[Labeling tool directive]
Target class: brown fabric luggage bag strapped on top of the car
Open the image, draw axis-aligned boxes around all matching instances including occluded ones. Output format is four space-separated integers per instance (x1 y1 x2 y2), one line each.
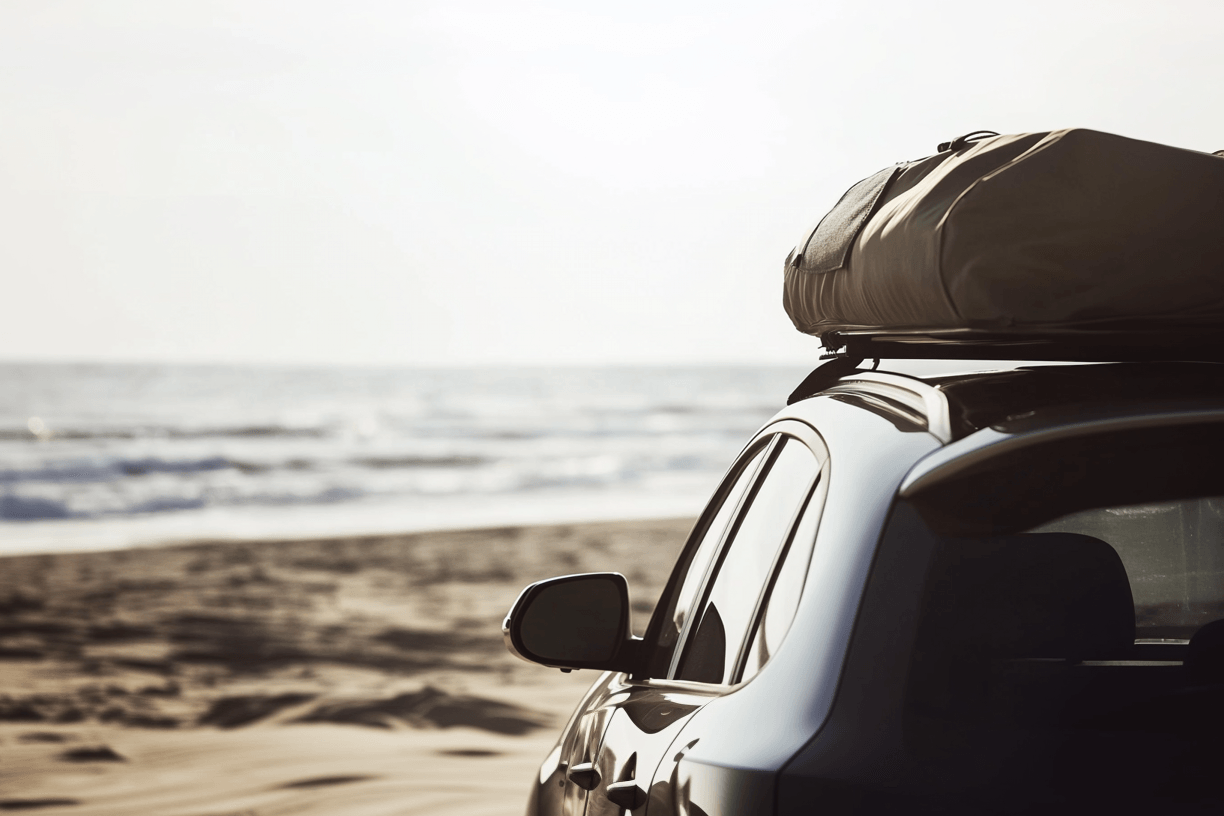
783 130 1224 358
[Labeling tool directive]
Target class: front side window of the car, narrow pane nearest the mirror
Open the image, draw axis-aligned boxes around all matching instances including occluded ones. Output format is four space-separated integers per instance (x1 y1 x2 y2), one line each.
647 437 772 677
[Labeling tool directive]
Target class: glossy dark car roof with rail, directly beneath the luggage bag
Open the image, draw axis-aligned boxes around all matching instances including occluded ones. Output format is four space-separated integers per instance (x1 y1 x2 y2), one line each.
819 360 1224 443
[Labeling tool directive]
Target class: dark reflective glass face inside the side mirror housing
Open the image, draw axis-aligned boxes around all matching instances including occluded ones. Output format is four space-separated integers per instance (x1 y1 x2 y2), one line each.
520 577 625 662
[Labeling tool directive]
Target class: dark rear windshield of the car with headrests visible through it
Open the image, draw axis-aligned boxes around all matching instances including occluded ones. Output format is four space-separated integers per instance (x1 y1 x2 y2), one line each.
905 498 1224 814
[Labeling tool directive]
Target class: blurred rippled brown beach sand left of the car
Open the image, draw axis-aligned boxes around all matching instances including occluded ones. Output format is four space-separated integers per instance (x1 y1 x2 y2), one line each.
0 519 692 816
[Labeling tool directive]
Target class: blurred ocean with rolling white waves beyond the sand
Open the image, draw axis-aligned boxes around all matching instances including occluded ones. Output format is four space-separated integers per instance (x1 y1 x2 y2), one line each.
0 363 807 554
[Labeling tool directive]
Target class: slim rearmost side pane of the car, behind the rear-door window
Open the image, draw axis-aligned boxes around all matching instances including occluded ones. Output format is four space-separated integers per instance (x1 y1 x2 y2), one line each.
736 464 824 680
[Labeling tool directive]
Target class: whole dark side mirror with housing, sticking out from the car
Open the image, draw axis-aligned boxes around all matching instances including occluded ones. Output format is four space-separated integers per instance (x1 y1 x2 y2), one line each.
502 573 641 672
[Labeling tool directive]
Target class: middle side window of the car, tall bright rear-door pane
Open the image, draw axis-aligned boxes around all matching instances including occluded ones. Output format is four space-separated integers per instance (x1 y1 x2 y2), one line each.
676 438 820 683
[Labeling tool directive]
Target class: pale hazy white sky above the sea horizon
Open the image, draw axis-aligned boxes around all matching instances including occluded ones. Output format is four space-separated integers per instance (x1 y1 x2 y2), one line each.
0 0 1224 365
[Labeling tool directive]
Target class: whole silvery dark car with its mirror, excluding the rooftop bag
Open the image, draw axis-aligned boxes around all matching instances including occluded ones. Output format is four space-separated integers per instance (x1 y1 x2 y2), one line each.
506 362 1224 816
